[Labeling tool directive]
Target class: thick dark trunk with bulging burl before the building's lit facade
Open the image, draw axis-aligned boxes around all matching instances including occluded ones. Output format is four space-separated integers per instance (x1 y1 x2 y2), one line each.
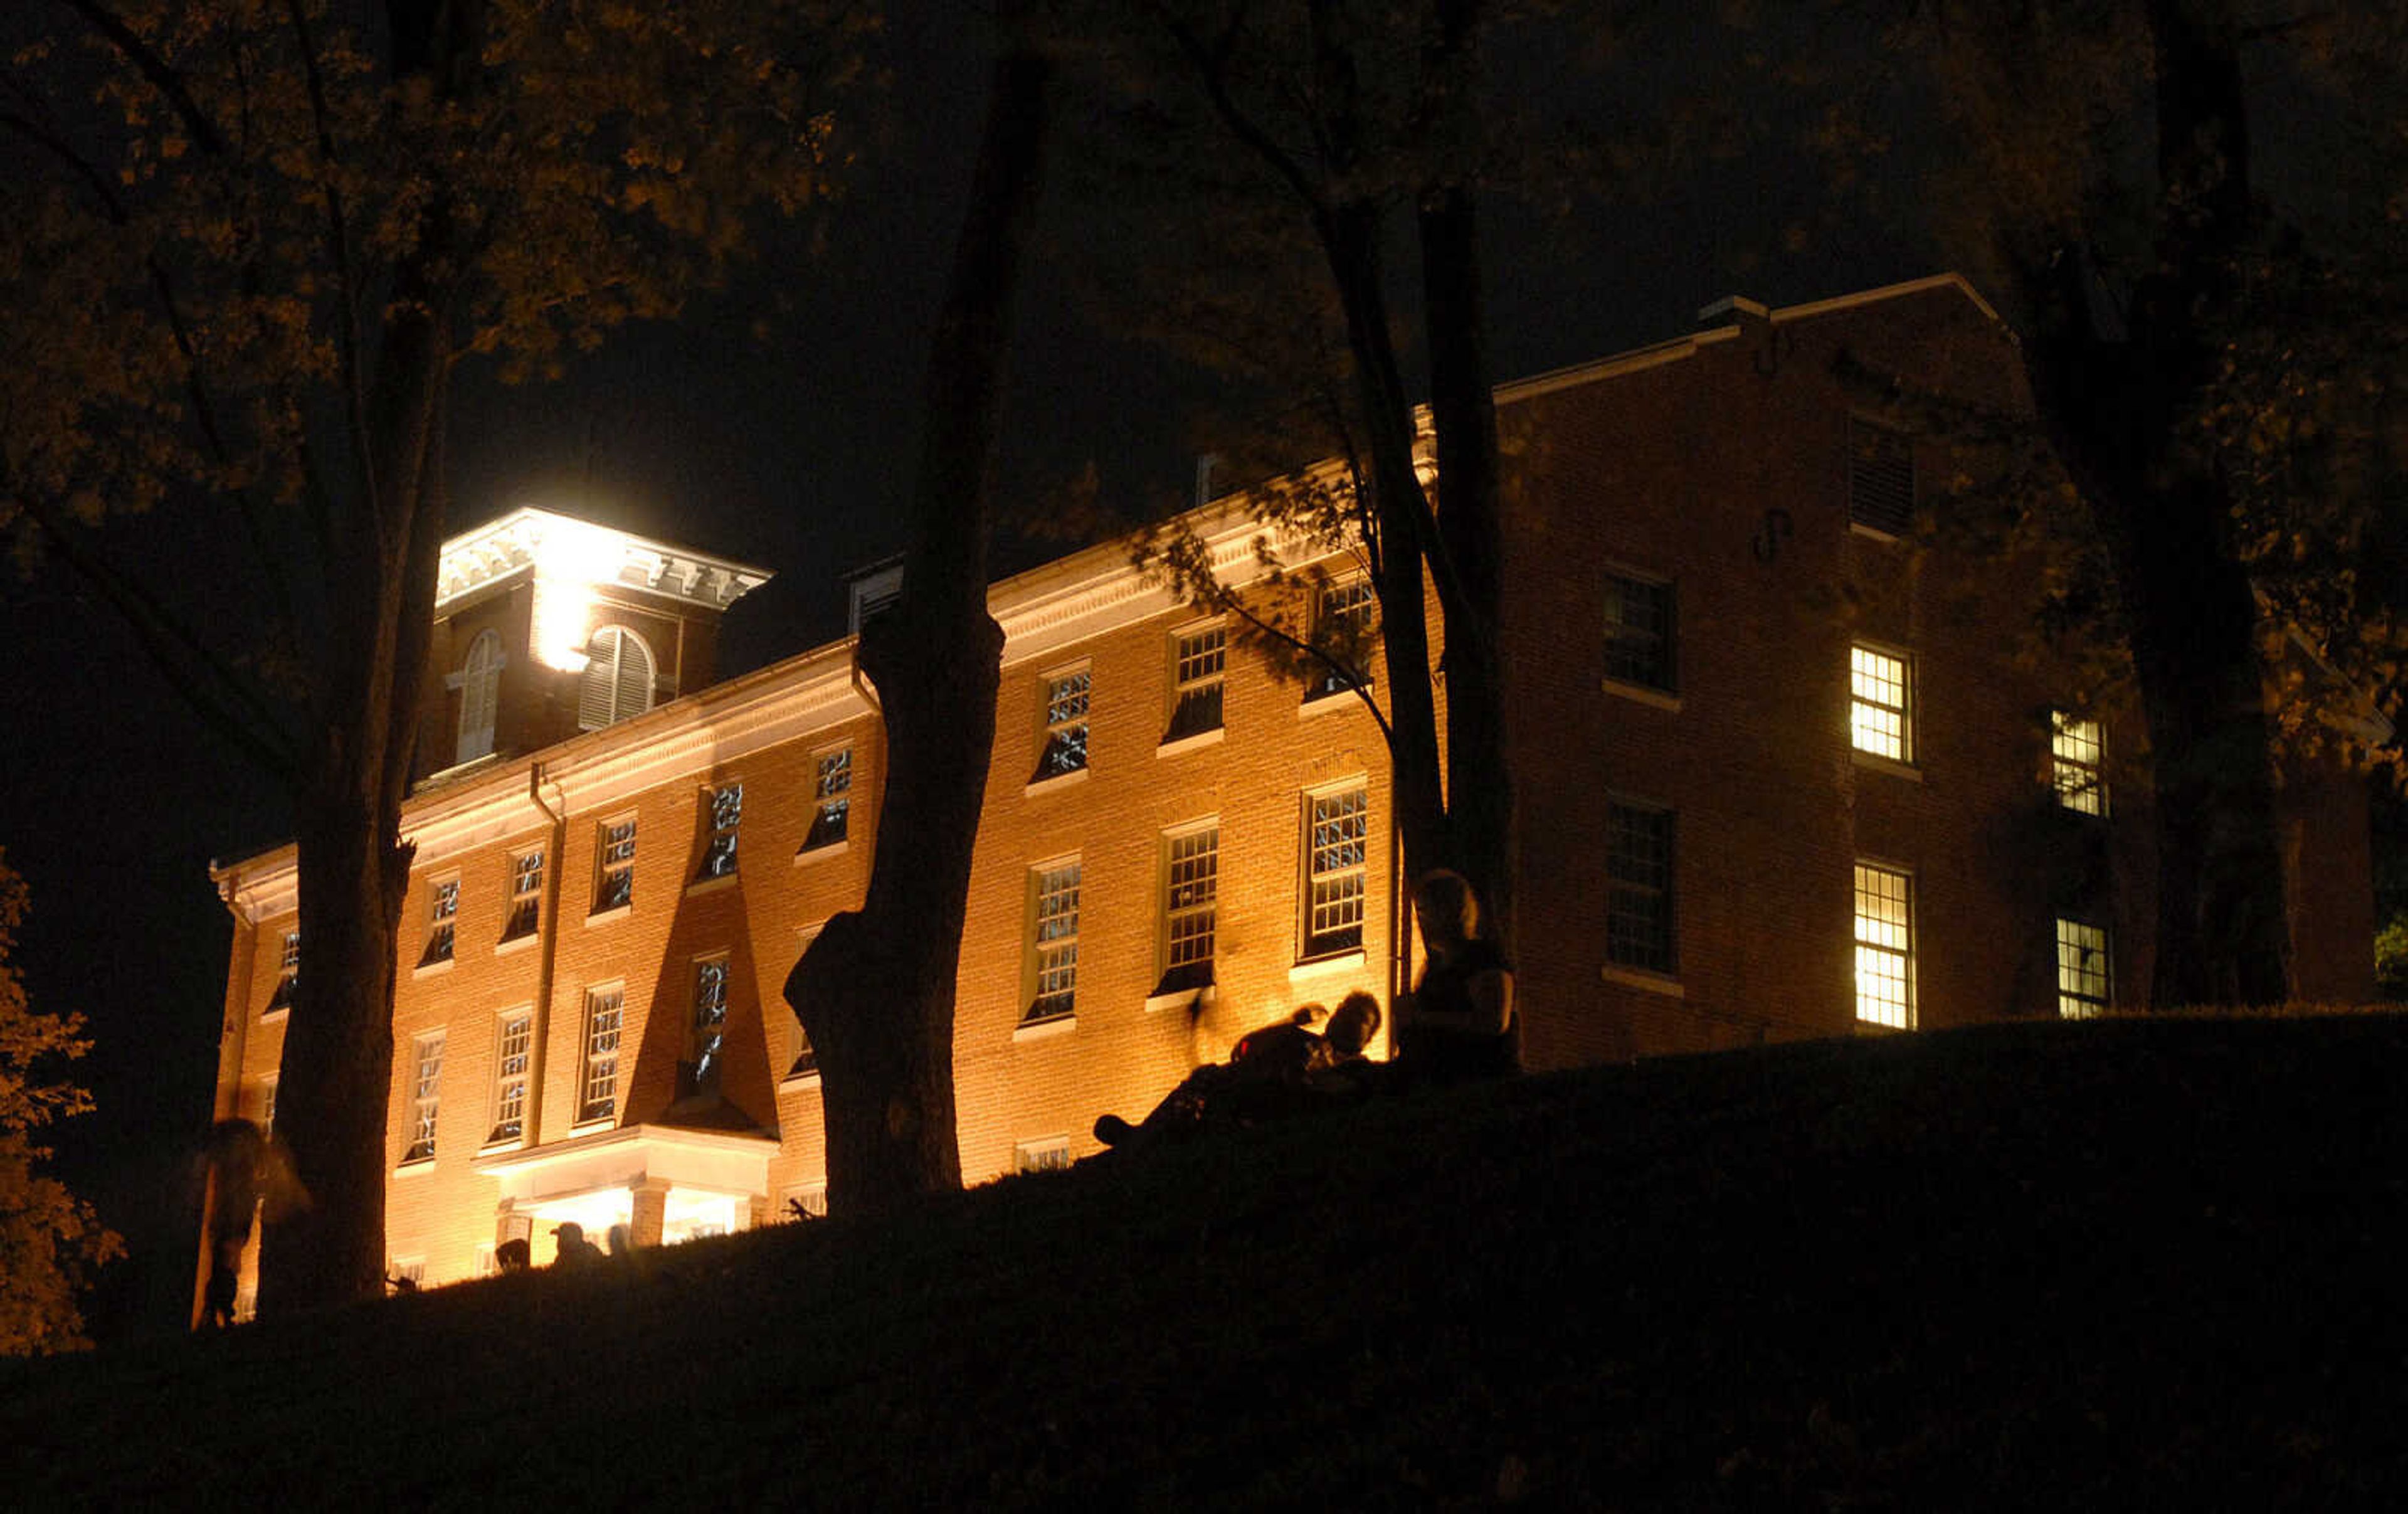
785 19 1050 1213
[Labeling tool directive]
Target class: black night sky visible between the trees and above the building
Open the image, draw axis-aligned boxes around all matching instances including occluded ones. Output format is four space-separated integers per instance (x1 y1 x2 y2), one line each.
0 5 1938 1336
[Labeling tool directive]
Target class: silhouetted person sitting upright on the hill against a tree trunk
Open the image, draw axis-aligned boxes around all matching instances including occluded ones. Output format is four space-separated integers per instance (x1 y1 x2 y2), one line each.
1397 869 1522 1086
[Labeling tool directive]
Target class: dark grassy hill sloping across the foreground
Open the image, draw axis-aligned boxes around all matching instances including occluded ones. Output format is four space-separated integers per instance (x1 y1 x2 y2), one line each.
0 1016 2408 1509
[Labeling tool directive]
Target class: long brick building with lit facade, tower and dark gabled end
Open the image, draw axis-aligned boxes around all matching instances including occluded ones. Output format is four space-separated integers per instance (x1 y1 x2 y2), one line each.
202 277 2372 1283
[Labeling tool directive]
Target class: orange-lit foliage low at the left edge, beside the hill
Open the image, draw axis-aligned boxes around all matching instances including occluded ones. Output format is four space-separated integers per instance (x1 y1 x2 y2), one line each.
0 852 125 1355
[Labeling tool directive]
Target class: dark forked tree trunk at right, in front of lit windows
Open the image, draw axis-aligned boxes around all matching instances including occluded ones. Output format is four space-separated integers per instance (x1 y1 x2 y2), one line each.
2013 0 2293 1006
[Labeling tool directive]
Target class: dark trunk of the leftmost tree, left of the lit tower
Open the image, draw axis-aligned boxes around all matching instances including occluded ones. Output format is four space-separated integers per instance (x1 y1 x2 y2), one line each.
260 3 474 1314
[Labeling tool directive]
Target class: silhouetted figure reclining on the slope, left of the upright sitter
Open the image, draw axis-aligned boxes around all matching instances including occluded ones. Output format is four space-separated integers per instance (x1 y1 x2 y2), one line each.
1096 992 1380 1148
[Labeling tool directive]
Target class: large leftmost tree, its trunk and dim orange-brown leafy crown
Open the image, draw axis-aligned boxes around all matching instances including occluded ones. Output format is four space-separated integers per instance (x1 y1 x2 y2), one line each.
0 0 862 1307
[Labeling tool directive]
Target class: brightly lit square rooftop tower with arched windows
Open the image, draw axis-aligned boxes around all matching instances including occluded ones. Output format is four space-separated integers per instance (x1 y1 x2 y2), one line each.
414 508 768 782
